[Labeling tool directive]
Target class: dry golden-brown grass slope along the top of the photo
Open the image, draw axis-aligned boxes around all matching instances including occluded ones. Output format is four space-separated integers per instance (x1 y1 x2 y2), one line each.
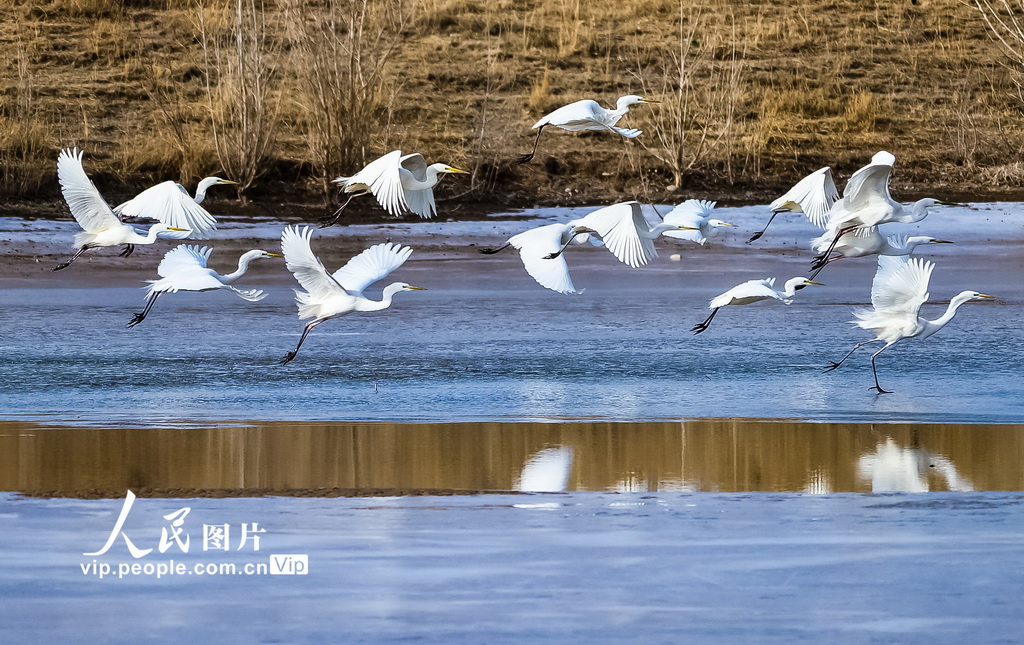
6 0 1024 203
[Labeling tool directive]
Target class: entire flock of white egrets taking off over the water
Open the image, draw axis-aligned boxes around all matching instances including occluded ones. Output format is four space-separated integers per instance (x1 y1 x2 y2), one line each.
48 95 992 394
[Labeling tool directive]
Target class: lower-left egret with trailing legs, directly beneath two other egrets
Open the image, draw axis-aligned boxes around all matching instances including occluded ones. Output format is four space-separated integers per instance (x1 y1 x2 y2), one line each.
128 245 282 328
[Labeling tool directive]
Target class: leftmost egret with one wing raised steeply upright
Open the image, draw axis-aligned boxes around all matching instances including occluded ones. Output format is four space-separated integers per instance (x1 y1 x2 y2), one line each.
53 147 188 271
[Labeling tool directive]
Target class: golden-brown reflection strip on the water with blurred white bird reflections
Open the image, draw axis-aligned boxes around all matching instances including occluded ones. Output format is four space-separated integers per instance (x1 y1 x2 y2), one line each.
0 420 1024 497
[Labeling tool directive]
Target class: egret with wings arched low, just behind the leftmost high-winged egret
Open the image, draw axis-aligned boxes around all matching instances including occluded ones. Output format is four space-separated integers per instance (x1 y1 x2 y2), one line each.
114 177 238 240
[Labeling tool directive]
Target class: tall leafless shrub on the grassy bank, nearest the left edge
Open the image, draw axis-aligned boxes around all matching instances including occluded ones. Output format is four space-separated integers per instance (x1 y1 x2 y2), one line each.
195 0 281 195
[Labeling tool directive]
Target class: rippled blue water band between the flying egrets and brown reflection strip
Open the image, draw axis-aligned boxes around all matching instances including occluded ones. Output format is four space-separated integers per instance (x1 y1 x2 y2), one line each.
0 250 1024 424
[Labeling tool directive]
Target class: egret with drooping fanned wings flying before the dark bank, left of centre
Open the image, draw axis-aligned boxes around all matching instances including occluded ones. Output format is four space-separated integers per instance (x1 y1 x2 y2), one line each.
321 151 469 228
